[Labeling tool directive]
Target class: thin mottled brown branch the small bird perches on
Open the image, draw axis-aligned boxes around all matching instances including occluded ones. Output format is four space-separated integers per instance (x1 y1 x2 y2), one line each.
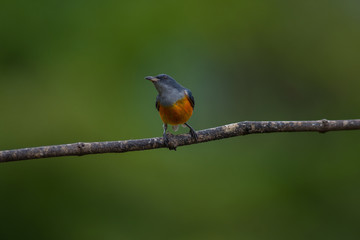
0 119 360 162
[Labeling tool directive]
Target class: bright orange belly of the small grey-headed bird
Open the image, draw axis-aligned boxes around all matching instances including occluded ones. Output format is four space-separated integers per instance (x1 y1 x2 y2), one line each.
159 97 193 125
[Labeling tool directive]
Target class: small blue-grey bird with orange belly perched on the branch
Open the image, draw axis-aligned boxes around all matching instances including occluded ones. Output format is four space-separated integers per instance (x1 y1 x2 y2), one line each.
145 74 198 144
